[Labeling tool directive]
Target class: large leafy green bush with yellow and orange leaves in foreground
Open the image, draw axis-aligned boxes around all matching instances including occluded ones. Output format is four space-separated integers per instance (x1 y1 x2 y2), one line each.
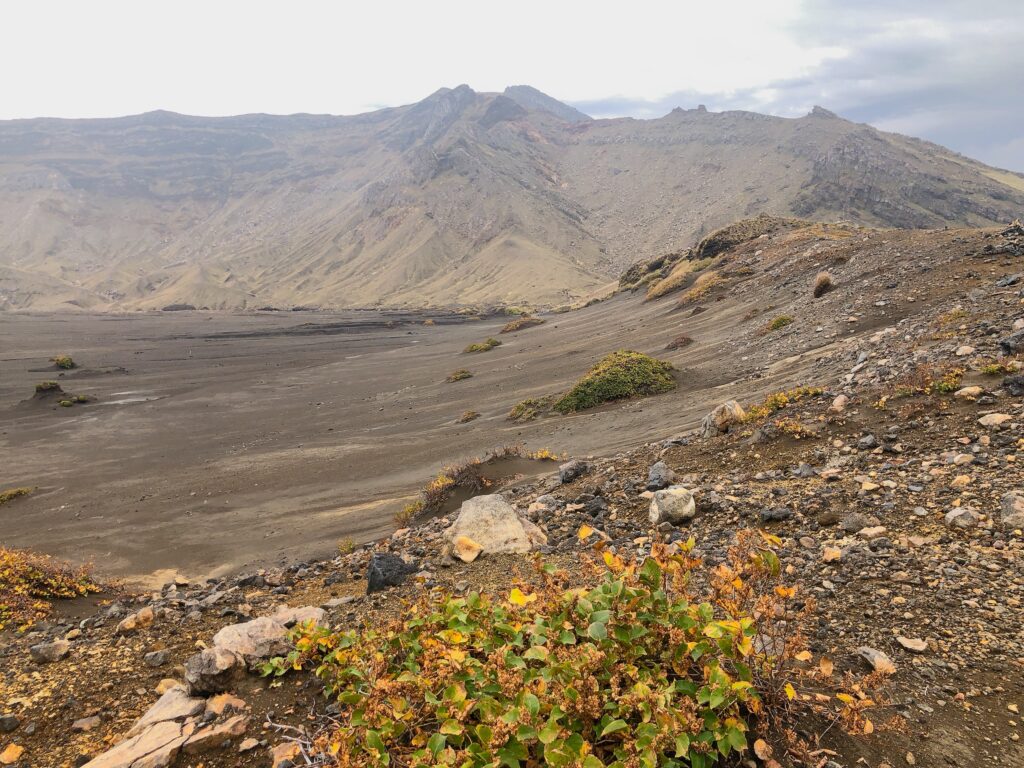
262 530 798 768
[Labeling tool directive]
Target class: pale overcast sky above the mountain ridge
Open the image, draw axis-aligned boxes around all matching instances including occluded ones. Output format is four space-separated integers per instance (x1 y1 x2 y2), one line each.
0 0 1024 171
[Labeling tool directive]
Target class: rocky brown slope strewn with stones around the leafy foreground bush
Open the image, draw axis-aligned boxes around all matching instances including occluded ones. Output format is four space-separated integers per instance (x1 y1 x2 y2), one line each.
0 222 1024 768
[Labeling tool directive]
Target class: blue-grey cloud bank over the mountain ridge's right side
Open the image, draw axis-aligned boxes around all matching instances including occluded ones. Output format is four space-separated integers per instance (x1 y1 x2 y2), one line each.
572 0 1024 172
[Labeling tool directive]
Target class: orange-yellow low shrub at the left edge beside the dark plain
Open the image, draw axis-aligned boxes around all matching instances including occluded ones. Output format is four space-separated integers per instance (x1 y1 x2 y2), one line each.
0 547 100 630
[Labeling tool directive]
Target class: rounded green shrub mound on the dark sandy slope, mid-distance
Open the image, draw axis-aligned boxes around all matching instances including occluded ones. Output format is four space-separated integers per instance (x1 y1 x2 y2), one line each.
554 349 676 414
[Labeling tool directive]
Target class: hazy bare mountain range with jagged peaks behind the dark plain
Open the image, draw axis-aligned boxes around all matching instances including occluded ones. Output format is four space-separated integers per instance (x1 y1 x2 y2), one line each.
0 85 1024 310
